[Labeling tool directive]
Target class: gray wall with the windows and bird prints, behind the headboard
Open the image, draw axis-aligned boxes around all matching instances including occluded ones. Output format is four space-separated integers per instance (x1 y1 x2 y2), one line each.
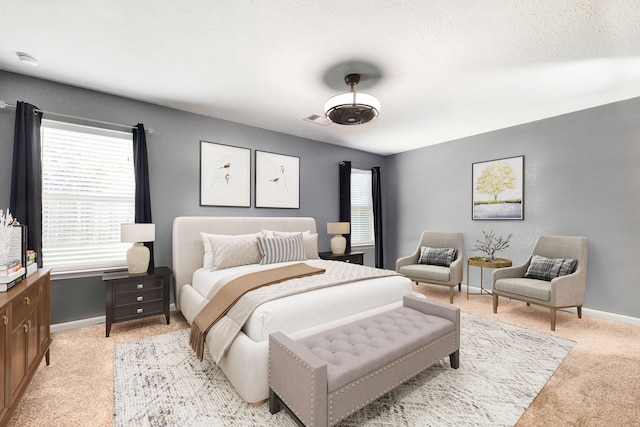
0 71 385 324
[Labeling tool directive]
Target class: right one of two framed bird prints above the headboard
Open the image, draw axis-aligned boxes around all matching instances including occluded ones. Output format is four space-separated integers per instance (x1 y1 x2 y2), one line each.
256 150 300 209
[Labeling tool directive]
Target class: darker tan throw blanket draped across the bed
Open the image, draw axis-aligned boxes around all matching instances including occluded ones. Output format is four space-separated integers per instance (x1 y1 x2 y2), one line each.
189 263 325 360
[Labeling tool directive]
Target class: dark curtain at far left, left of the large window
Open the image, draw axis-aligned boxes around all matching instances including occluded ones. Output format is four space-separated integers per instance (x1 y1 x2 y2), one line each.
9 101 42 267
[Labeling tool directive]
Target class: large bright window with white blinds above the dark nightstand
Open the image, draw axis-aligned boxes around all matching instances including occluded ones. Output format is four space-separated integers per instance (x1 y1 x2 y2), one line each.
42 120 135 272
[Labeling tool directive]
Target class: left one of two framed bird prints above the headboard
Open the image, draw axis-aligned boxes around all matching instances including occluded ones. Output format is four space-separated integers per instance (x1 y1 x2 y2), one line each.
200 141 251 208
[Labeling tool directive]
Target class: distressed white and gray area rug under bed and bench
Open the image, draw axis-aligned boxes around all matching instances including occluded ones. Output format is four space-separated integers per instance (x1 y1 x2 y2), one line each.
113 313 575 427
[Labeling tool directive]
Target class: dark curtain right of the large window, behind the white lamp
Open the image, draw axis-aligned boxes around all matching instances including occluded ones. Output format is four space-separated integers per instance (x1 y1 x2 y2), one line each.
133 123 155 273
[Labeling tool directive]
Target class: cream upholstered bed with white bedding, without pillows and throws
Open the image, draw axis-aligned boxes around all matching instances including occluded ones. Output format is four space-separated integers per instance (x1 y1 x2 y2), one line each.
172 217 411 404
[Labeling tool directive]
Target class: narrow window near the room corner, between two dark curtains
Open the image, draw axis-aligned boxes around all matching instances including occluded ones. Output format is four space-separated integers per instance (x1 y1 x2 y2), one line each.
351 168 375 246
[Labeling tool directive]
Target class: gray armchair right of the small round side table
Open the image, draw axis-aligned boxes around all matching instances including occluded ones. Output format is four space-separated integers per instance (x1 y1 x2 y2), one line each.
492 236 587 331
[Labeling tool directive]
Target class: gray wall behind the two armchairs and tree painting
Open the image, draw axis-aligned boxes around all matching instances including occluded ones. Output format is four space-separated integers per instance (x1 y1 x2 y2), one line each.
385 98 640 317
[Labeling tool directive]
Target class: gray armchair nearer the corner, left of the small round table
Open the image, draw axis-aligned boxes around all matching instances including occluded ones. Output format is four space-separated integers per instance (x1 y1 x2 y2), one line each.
396 231 464 304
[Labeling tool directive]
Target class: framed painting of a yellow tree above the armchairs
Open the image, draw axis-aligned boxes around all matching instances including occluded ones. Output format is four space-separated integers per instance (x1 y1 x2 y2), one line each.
472 156 524 219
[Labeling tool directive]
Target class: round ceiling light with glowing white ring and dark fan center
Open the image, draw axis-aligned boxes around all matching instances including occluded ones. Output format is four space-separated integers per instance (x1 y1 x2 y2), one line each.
324 74 380 125
